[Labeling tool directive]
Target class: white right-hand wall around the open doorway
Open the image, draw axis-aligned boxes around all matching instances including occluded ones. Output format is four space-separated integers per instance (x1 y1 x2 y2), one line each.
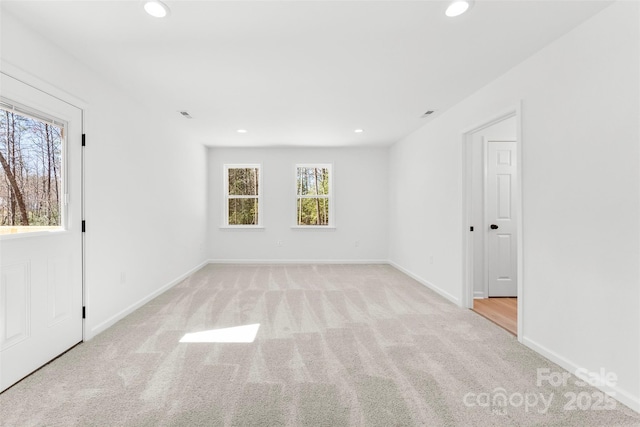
389 1 640 410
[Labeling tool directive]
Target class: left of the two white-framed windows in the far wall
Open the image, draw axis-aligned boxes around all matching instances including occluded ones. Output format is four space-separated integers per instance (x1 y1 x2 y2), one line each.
224 165 262 227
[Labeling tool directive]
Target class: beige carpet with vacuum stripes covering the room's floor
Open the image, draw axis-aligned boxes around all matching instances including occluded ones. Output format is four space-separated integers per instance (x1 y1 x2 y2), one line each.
0 265 640 427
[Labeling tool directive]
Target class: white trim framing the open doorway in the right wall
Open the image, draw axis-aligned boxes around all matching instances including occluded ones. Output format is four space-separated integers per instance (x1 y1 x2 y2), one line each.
461 101 525 342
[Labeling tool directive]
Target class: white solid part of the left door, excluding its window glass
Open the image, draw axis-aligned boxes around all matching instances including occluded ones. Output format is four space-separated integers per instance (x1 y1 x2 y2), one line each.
0 74 83 390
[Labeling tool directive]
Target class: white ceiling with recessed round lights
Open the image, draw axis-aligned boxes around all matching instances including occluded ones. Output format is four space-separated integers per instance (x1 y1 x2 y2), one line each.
1 0 610 146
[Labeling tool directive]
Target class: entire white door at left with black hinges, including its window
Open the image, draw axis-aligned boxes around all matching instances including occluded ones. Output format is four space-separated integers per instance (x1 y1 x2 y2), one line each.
0 74 83 391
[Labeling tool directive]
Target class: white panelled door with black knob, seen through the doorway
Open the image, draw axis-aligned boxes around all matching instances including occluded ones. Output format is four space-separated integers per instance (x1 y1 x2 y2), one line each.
485 140 518 297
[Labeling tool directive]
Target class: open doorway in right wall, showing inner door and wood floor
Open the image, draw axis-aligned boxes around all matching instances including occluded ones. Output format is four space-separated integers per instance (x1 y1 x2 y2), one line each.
463 107 523 337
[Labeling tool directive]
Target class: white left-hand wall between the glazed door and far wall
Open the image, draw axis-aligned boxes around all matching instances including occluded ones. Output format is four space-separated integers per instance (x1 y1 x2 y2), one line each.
1 12 206 339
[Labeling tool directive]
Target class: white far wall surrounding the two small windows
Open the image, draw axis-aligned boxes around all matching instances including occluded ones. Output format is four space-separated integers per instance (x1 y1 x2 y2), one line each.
208 148 388 262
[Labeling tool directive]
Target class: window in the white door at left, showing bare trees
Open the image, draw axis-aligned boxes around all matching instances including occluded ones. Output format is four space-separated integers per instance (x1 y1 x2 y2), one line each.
0 101 65 234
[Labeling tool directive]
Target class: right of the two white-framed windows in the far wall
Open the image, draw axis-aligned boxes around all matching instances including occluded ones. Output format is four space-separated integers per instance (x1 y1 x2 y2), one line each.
296 164 333 227
